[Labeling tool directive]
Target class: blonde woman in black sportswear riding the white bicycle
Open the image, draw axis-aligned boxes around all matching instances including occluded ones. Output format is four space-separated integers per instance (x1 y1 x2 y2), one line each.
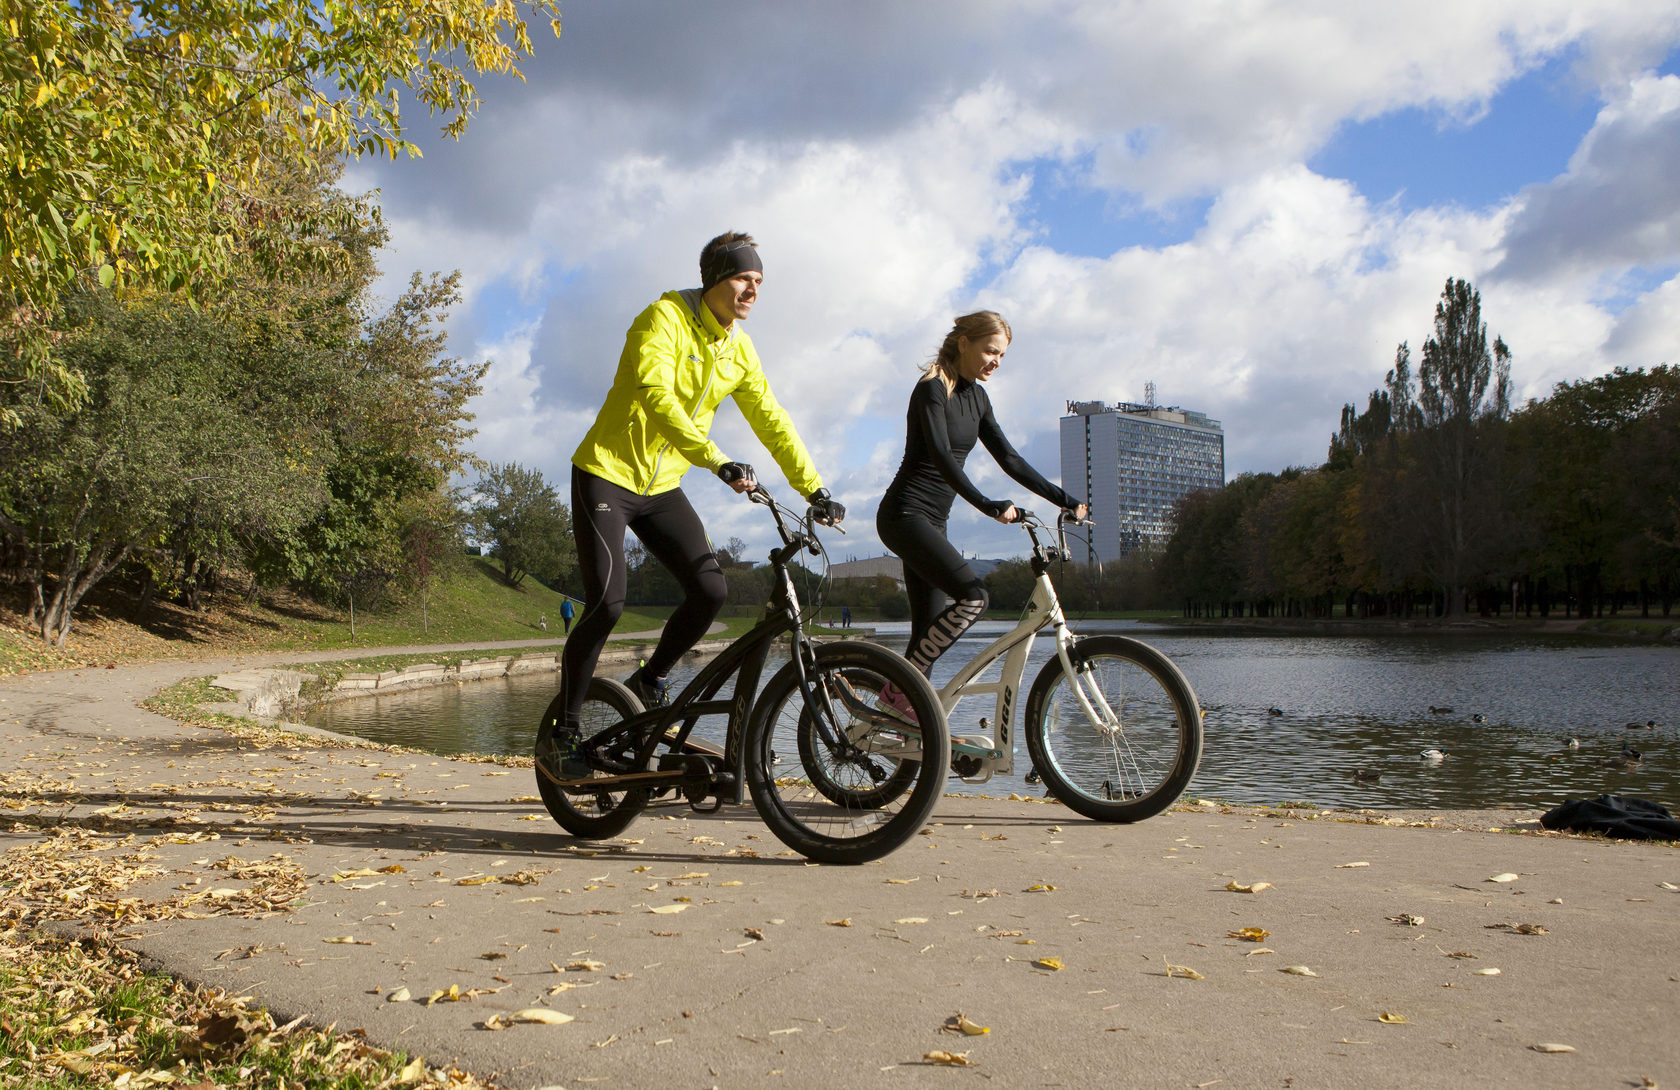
875 311 1087 710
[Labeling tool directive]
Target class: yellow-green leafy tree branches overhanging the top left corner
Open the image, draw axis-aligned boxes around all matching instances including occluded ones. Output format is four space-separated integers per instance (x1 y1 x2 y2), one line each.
0 0 559 418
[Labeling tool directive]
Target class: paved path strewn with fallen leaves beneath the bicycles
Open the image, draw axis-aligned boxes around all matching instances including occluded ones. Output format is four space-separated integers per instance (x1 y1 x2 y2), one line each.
0 648 1680 1090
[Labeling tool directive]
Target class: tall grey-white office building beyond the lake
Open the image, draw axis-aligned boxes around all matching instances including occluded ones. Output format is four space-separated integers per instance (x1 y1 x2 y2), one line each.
1062 398 1225 561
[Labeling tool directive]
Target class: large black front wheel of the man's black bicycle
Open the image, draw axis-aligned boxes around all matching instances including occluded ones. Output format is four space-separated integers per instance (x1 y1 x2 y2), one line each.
744 642 951 863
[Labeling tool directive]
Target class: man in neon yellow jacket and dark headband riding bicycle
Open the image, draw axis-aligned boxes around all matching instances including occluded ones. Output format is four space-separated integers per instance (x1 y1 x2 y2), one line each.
536 232 845 783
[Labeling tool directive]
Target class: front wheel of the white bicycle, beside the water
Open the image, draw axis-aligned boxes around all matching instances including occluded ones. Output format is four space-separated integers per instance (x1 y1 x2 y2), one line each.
1025 635 1201 821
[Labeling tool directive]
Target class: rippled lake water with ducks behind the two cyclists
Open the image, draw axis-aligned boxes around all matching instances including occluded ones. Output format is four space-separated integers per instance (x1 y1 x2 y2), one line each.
309 621 1680 810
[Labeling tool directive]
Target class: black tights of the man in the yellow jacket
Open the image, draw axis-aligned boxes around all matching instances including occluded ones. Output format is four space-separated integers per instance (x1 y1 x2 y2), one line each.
559 465 729 722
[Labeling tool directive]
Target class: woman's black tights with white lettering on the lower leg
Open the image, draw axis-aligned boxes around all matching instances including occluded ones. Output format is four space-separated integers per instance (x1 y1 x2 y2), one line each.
875 516 988 675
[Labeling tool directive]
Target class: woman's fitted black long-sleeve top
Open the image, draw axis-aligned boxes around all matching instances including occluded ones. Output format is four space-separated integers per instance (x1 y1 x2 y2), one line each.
880 376 1079 522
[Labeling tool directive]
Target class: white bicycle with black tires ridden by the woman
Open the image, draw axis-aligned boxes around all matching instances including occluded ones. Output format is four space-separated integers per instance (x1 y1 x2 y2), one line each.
798 512 1201 821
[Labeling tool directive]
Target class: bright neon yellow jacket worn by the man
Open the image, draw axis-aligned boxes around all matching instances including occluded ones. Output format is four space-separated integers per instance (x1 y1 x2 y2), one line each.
571 289 823 497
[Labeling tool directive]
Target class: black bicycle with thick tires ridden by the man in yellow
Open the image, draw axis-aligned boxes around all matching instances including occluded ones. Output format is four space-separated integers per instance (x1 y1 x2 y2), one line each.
536 489 949 863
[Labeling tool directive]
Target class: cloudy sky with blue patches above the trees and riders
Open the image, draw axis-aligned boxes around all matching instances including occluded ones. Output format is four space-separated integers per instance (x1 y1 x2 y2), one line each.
346 0 1680 559
